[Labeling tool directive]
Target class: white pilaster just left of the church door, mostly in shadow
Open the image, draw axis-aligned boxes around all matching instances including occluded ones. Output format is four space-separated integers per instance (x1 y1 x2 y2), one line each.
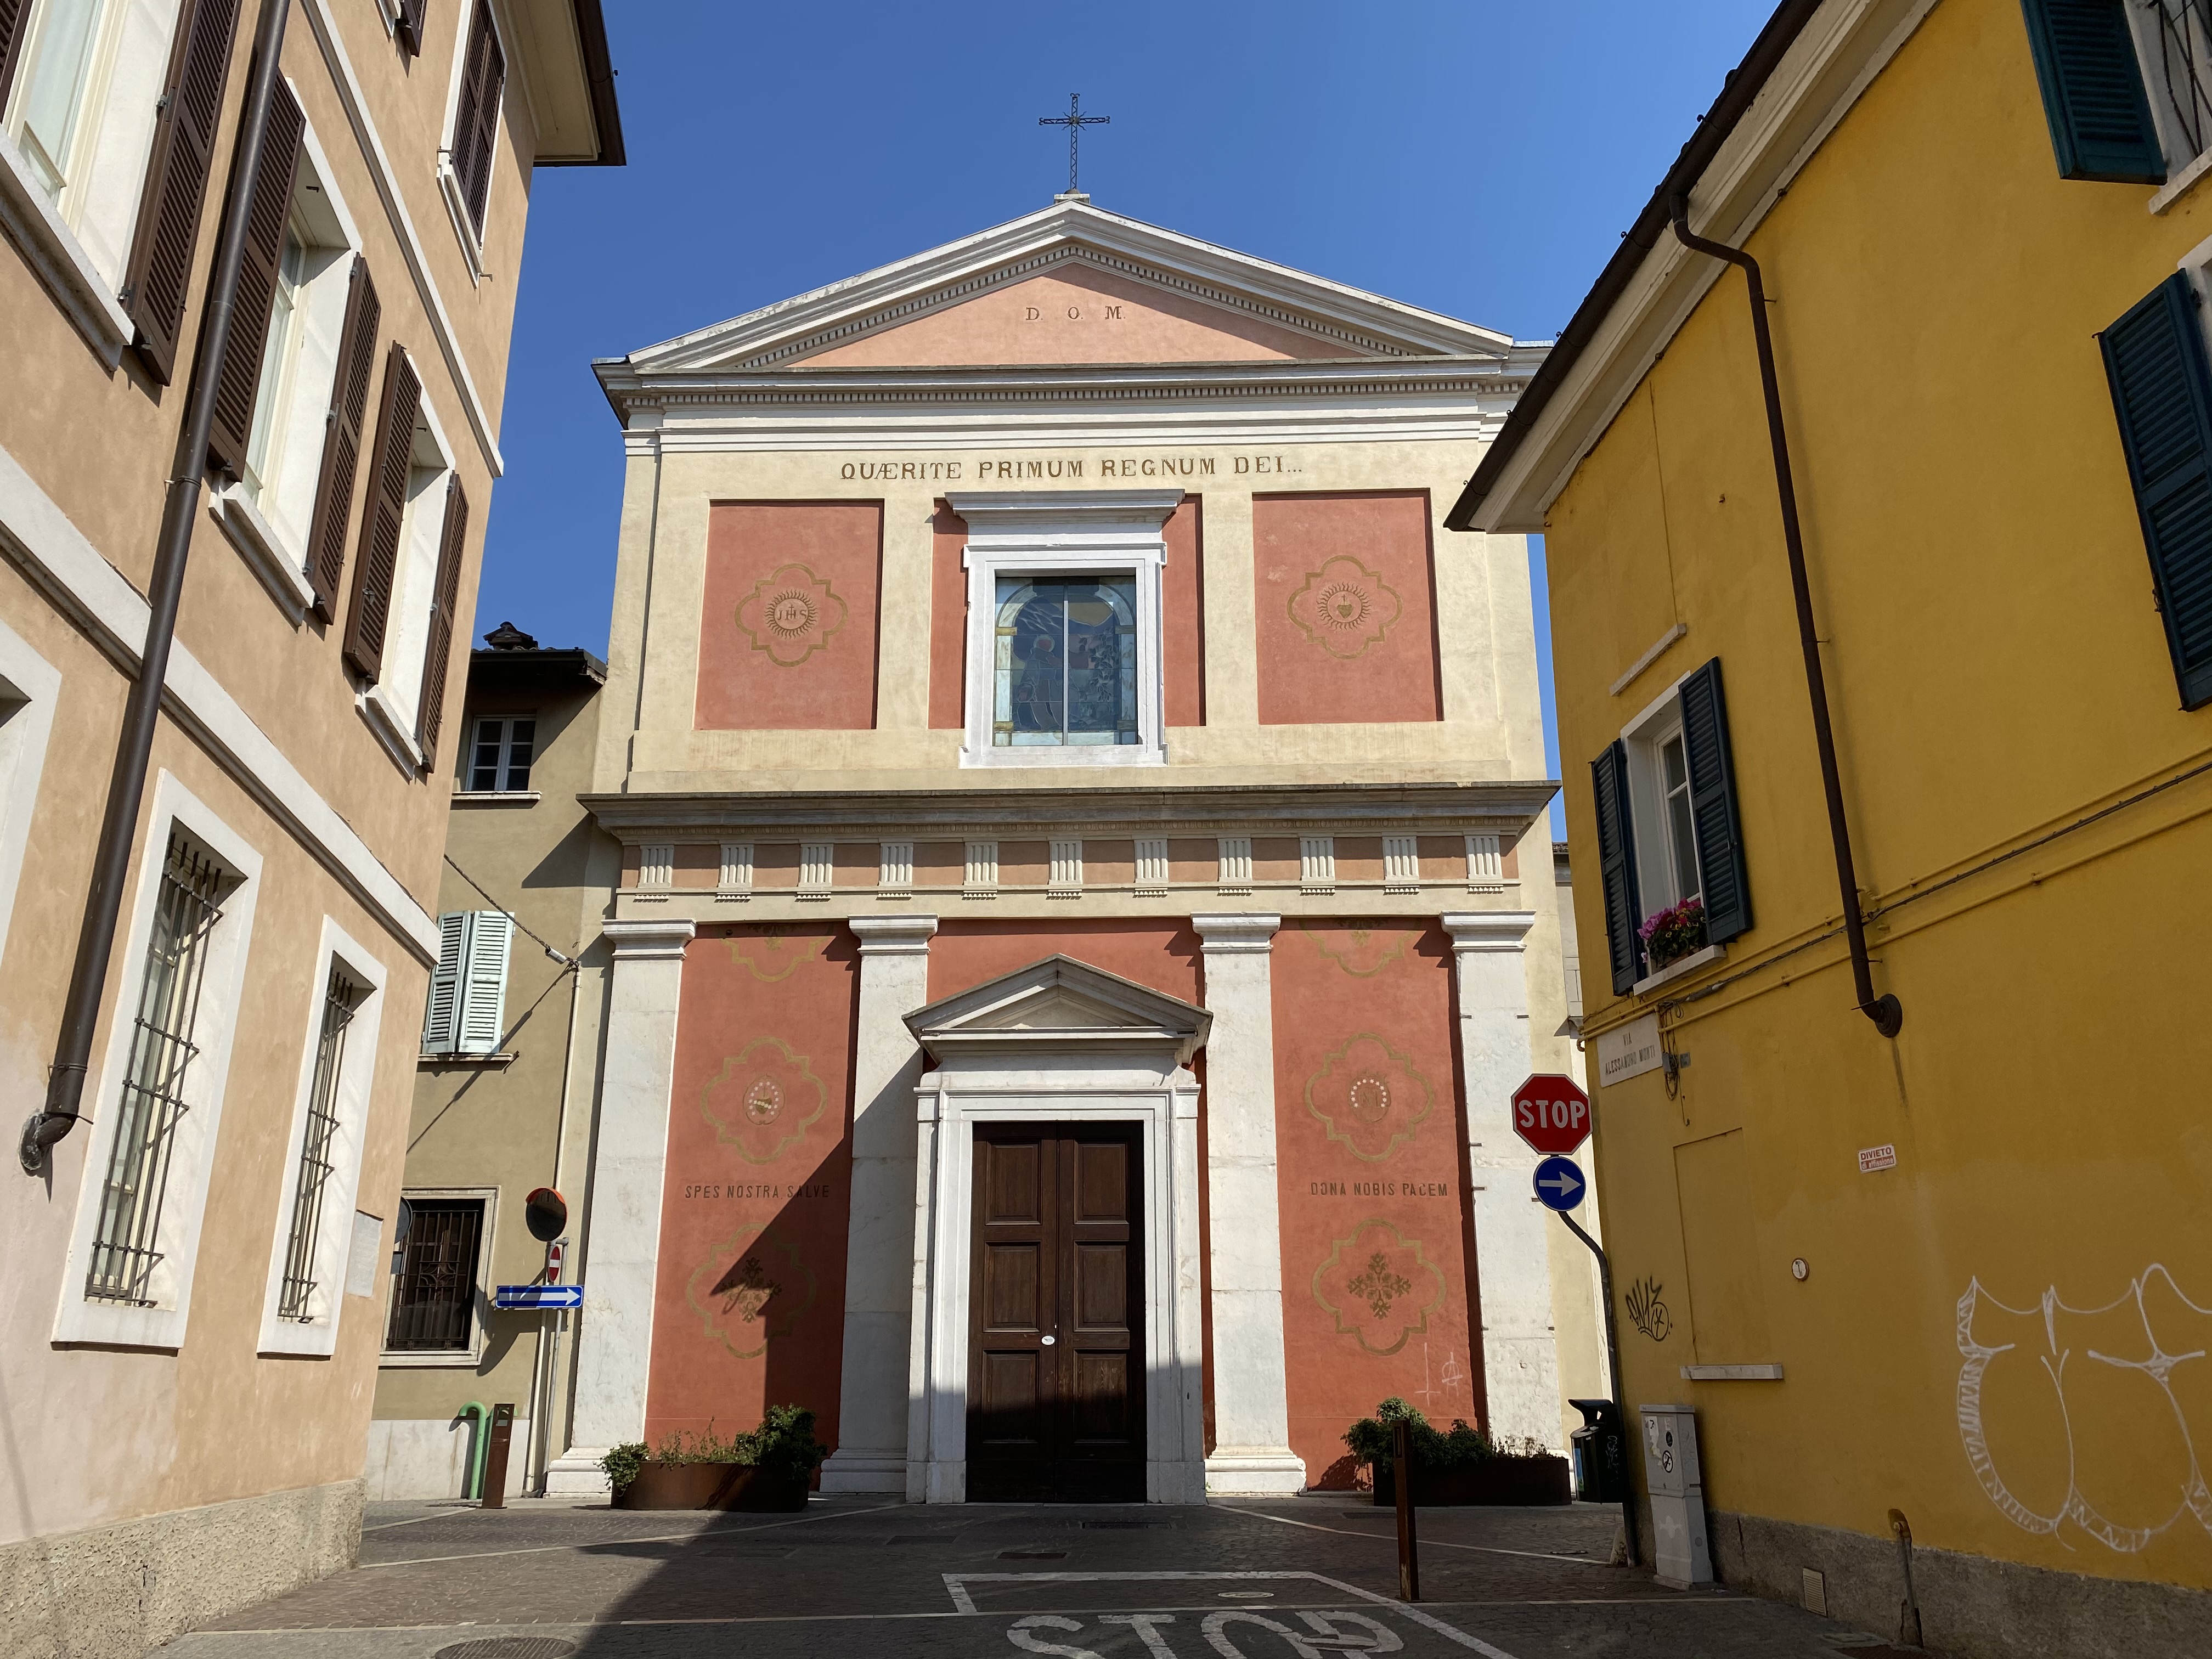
823 916 938 1493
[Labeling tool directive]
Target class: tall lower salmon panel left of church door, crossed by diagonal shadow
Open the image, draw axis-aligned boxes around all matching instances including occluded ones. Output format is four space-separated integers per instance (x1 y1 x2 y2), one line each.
646 922 860 1447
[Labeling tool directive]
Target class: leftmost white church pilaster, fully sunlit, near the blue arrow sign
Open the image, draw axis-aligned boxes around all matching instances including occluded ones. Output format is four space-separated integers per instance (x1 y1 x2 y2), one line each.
546 918 697 1496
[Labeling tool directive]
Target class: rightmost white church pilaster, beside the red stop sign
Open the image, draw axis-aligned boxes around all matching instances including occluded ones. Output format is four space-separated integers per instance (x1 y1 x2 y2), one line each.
1442 911 1560 1444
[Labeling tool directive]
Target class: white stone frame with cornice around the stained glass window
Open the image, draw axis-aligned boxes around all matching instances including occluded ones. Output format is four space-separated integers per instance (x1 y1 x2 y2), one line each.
947 489 1183 768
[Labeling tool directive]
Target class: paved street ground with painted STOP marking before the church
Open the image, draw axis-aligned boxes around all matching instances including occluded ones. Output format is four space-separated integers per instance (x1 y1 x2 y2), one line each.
168 1498 1887 1659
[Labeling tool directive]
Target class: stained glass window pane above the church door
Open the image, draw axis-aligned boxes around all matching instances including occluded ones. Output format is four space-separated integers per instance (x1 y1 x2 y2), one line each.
991 575 1139 748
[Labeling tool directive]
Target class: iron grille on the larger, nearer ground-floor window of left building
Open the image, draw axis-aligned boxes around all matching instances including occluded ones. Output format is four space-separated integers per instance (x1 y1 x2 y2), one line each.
84 830 230 1307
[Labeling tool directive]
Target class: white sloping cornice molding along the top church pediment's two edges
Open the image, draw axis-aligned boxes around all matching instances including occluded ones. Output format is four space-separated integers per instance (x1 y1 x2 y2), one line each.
624 201 1513 371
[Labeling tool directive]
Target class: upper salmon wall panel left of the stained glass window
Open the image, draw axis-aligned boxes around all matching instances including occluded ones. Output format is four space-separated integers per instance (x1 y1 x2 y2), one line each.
695 502 883 732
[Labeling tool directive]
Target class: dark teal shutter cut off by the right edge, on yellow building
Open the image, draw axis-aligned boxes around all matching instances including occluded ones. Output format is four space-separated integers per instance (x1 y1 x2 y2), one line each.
2097 272 2212 708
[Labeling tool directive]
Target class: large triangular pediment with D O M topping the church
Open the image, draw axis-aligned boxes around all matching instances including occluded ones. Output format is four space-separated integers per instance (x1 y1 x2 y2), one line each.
628 201 1513 374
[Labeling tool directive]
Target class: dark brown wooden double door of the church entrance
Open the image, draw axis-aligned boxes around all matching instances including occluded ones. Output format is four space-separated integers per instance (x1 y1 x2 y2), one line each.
967 1124 1146 1502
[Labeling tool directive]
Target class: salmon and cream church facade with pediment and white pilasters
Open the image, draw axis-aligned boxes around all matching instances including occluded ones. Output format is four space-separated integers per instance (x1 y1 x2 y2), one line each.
551 195 1604 1502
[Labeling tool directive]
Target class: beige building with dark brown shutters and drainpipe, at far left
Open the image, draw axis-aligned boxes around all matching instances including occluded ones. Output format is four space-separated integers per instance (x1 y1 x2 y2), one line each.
0 0 622 1659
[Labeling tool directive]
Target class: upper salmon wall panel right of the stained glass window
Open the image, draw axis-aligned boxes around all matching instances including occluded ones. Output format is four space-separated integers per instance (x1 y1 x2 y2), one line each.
1252 491 1444 725
